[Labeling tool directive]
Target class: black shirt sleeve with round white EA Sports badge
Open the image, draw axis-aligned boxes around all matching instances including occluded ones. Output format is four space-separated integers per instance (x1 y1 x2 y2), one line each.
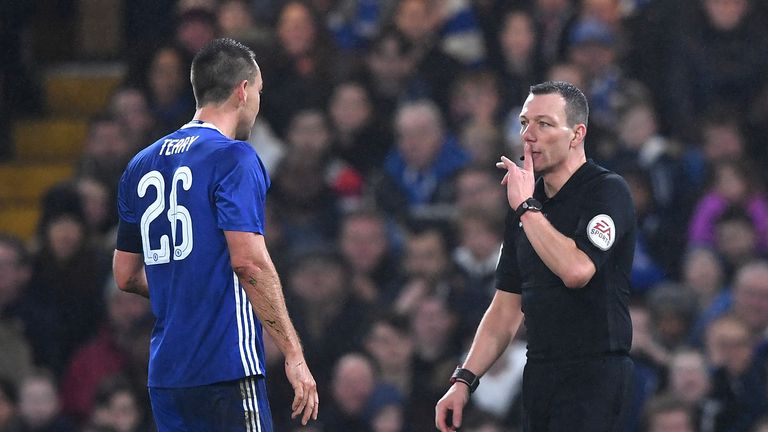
573 174 635 270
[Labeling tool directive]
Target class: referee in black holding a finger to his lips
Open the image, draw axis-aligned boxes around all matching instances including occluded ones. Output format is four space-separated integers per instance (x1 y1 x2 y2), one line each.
435 82 635 432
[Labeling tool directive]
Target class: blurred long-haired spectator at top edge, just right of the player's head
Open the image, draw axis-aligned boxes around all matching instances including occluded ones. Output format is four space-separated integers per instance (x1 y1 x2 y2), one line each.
262 0 339 136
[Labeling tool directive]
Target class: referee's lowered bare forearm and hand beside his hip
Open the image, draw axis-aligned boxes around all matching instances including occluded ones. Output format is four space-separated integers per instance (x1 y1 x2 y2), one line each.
435 290 523 432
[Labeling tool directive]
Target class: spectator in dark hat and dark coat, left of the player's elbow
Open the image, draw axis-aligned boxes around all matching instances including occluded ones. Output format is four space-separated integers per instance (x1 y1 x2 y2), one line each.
24 183 110 376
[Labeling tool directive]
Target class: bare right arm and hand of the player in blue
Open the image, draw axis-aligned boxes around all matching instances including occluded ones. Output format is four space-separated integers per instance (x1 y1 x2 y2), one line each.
224 231 319 424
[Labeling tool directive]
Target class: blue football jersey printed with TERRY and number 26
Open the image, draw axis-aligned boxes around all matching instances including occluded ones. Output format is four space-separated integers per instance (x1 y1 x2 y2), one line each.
118 121 270 387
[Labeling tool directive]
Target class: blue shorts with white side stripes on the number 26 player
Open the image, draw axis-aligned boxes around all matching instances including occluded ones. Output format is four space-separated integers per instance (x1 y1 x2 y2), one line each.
149 375 272 432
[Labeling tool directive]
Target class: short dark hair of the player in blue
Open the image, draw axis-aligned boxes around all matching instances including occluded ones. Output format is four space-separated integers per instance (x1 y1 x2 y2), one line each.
190 38 259 108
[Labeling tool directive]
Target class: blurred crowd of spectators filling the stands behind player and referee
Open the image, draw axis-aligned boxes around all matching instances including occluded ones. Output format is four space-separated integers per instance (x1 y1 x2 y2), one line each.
0 0 768 432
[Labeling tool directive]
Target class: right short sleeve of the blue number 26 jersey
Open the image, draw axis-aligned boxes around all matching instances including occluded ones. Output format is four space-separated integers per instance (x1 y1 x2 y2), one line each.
213 141 269 234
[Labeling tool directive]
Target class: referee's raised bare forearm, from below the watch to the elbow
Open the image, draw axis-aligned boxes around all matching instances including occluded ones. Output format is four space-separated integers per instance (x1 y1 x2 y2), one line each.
520 211 597 288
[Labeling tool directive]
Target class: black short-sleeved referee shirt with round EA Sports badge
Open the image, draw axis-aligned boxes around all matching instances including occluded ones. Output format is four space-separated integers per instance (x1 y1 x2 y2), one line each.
496 160 636 362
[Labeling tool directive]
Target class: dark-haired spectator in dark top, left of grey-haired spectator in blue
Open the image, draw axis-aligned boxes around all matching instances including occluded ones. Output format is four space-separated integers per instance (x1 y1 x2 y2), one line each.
328 80 392 175
